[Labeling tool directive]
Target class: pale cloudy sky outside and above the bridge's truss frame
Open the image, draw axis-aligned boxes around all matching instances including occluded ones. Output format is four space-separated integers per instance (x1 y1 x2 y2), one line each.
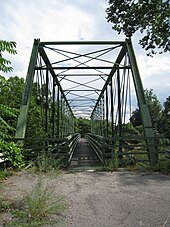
0 0 170 103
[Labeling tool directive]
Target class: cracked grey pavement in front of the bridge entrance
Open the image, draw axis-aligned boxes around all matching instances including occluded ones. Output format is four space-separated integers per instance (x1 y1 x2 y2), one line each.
3 171 170 227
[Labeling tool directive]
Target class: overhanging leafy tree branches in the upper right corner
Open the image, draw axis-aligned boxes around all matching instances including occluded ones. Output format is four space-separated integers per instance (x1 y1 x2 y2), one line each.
106 0 170 55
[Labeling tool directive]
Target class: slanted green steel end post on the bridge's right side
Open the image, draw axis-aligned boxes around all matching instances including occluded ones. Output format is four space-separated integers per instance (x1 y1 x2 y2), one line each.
126 39 158 164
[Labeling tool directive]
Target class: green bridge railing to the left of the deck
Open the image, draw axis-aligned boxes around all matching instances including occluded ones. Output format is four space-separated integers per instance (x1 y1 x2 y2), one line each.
14 133 80 166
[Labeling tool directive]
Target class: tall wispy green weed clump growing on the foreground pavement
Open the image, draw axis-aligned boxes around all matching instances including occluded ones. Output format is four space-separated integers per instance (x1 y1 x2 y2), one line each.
8 179 67 227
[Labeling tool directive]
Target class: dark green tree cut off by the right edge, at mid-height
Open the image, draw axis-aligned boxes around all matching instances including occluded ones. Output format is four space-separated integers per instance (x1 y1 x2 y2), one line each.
160 96 170 137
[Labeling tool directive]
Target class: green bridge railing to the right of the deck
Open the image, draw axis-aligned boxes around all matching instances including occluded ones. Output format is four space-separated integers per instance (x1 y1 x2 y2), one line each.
86 133 170 164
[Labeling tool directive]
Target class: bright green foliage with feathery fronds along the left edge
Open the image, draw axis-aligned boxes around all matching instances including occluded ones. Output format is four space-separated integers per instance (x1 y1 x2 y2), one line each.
0 40 24 168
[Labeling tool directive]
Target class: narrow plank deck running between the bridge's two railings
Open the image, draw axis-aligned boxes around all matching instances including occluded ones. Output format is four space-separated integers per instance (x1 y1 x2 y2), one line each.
70 138 100 167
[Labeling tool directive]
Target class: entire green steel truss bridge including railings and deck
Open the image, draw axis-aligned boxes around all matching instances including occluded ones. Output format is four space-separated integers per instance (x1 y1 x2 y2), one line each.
15 39 169 166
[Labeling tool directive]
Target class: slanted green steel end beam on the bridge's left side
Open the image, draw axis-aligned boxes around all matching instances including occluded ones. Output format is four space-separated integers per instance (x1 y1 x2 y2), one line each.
15 39 40 138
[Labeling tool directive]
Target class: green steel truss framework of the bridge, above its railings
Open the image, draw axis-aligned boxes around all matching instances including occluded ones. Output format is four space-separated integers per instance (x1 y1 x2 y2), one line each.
16 39 157 163
